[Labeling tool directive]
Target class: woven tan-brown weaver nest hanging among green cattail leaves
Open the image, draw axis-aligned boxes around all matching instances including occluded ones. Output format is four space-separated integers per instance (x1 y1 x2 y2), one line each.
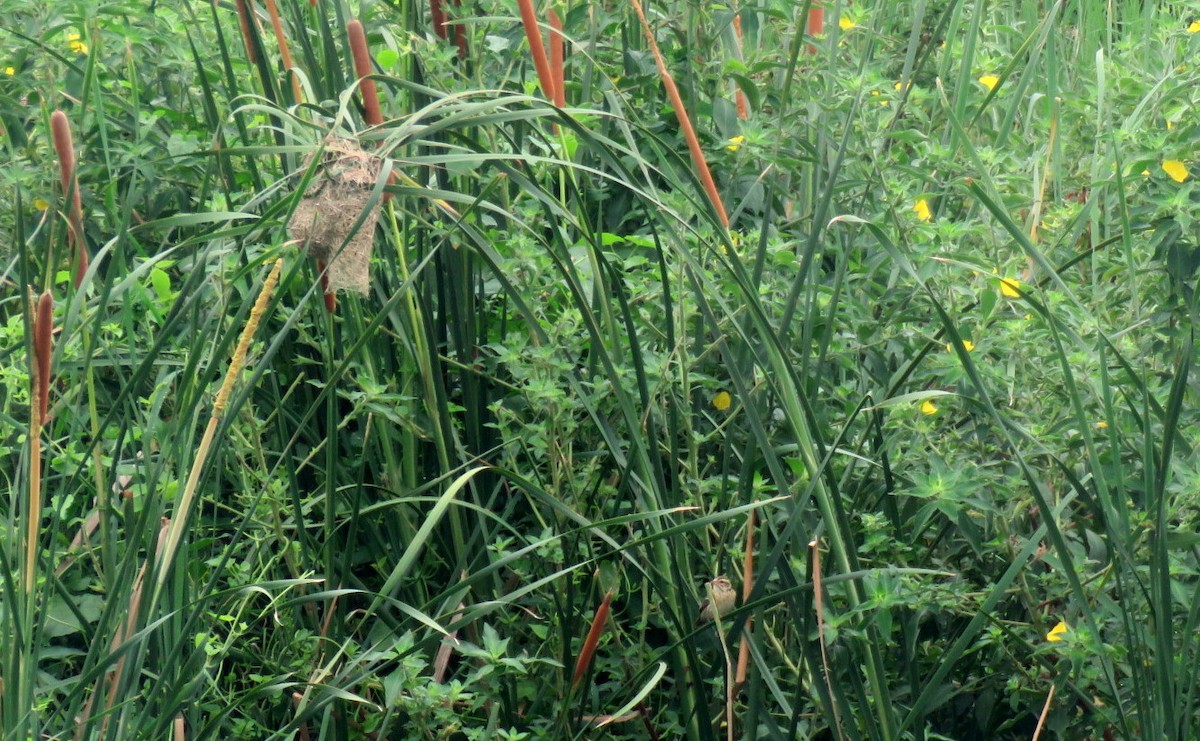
288 137 382 294
